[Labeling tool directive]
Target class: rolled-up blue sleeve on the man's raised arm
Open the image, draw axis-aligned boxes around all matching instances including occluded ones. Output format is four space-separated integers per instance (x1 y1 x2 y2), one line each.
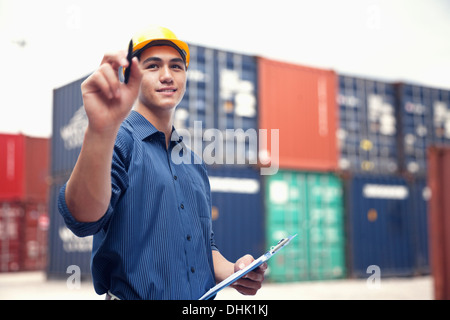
58 127 132 237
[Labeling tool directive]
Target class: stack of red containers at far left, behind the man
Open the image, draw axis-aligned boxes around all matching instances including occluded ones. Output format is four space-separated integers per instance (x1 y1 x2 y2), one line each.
0 134 49 272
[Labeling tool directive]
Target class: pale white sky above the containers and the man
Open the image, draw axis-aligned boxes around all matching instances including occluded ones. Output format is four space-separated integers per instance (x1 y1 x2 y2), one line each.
0 0 450 137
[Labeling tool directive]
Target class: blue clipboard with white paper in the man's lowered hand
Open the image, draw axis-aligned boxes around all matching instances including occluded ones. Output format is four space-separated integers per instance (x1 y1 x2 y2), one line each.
199 234 297 300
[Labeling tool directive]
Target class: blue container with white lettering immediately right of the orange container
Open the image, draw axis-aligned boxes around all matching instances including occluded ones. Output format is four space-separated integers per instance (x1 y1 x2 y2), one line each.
337 75 399 174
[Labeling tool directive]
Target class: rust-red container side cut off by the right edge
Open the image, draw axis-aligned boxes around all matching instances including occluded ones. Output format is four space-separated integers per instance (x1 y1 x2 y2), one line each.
428 148 450 300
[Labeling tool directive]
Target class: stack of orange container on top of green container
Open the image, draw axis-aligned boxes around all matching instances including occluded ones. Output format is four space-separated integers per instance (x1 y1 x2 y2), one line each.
258 58 346 282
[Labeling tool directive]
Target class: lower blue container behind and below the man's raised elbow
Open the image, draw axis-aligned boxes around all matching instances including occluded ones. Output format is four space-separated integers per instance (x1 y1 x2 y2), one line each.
47 176 93 278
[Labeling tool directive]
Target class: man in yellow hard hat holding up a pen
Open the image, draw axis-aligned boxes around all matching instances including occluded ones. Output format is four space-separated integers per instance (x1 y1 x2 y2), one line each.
58 27 267 299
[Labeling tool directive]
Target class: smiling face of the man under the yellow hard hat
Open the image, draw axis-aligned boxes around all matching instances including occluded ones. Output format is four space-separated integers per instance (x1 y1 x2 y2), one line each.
139 46 186 110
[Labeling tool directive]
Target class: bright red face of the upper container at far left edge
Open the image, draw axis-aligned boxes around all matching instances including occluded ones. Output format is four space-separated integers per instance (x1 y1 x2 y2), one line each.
0 134 25 200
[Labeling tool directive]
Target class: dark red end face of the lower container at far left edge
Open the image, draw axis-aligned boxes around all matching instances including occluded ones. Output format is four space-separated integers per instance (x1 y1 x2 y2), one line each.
0 203 23 272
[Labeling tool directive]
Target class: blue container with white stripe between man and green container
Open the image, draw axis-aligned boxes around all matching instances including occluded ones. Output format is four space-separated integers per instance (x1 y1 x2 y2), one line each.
208 166 267 261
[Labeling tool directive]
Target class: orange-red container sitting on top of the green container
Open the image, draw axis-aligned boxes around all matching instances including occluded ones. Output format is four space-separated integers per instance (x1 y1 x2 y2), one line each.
258 58 338 171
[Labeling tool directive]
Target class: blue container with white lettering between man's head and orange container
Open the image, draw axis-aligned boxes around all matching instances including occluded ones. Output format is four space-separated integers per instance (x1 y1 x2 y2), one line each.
174 45 258 164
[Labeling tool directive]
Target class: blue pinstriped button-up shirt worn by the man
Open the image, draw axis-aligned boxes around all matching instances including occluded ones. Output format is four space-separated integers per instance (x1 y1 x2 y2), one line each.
58 111 217 300
